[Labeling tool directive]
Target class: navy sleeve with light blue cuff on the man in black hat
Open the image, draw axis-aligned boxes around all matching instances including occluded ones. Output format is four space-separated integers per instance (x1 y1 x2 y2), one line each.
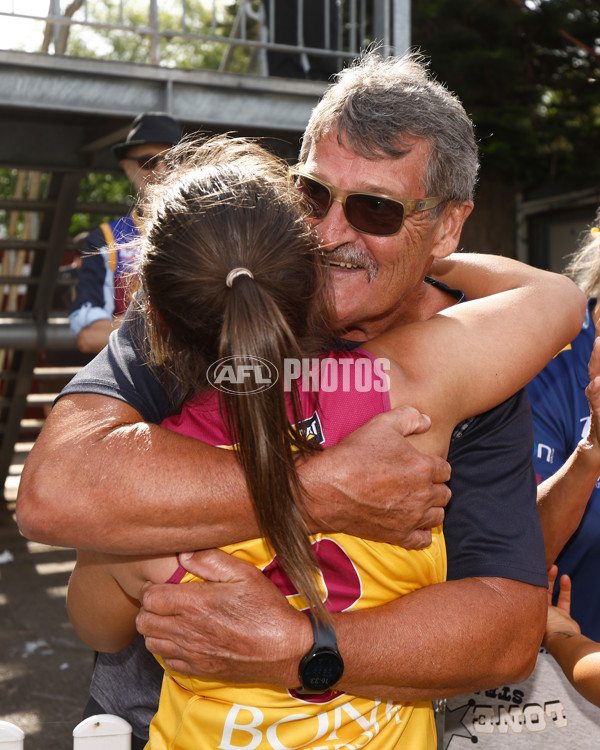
69 228 115 336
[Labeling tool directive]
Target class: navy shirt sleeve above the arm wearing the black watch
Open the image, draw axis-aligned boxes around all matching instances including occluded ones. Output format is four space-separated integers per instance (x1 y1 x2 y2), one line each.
444 390 548 586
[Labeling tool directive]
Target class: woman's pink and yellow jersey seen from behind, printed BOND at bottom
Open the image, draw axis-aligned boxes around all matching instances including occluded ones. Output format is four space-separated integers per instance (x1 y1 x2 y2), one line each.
150 349 446 750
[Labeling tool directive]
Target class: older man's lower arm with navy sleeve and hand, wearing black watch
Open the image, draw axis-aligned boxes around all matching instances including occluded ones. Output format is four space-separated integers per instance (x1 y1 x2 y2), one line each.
138 392 547 701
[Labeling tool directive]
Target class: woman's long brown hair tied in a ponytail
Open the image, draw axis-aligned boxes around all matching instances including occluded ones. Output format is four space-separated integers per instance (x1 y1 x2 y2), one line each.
135 137 328 619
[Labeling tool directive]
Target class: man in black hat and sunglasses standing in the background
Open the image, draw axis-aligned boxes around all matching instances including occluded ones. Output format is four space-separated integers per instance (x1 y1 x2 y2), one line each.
69 112 182 353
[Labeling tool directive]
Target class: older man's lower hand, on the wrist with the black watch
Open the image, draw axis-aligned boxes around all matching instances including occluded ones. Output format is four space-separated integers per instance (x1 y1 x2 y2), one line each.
136 550 312 687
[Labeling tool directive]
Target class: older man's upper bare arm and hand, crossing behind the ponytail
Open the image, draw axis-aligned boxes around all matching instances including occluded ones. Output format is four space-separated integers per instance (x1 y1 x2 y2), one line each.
17 394 450 554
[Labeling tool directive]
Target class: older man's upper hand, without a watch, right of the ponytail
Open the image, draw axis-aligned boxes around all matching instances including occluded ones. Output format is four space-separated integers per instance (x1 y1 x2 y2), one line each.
301 406 450 549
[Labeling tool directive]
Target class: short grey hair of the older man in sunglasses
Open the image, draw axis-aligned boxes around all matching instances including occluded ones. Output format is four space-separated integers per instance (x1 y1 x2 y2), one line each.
300 50 479 202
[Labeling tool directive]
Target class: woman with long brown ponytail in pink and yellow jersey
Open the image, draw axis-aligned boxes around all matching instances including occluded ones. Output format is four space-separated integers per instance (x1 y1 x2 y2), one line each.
68 137 585 750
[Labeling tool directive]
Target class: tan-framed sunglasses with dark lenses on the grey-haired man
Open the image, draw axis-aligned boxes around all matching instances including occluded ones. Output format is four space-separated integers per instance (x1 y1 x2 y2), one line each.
290 165 443 237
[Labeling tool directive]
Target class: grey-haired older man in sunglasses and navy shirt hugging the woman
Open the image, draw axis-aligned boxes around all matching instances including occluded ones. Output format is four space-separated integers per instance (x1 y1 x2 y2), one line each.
18 54 546 750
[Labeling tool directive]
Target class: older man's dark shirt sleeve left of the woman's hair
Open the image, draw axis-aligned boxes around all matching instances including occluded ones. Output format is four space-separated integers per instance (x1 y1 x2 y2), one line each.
59 313 176 424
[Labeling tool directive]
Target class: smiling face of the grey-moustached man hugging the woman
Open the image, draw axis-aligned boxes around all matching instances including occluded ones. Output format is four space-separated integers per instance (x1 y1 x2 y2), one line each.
302 134 450 340
